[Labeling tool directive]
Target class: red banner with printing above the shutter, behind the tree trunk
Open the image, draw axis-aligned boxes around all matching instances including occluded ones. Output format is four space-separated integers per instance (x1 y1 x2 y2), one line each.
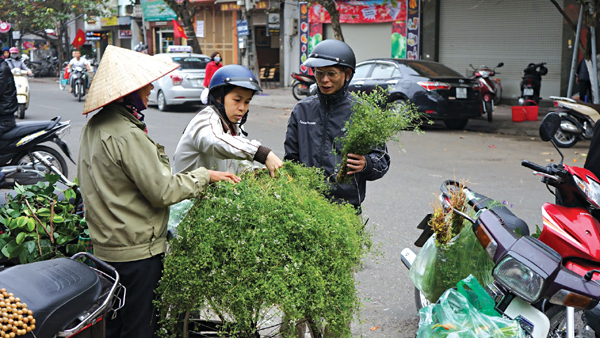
309 1 406 24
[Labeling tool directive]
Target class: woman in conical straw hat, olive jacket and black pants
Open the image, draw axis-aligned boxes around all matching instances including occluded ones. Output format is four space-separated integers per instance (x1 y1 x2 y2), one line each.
77 46 240 338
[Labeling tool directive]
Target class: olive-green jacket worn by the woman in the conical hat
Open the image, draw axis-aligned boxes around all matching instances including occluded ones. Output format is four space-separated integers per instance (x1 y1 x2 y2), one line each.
77 103 210 262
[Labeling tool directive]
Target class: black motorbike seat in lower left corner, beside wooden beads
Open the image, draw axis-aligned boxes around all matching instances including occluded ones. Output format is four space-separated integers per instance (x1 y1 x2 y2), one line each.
0 258 102 338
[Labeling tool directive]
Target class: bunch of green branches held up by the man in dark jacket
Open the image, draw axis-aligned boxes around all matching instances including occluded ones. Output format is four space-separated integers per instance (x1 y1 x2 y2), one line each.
336 88 421 183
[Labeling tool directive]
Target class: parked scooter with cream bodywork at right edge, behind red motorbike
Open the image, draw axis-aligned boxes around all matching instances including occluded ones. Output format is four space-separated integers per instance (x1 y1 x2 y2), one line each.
550 96 600 148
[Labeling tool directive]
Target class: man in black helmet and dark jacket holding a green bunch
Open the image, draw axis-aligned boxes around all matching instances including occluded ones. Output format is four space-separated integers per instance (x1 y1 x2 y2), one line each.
284 39 390 210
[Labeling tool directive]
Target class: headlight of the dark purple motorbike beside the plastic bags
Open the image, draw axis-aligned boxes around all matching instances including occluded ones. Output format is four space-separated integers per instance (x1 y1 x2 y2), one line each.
493 255 544 303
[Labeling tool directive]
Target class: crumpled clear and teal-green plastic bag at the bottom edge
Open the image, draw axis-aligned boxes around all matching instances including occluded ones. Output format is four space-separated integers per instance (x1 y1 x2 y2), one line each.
417 276 525 338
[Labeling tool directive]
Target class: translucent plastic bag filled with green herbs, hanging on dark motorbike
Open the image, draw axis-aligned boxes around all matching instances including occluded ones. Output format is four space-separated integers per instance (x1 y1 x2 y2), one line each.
409 225 494 303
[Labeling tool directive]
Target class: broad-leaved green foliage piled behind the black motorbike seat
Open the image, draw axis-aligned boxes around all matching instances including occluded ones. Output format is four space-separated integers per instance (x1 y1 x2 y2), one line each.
0 175 88 264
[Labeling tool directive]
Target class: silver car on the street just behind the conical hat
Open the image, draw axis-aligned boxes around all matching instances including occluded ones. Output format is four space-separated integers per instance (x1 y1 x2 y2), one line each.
148 53 210 111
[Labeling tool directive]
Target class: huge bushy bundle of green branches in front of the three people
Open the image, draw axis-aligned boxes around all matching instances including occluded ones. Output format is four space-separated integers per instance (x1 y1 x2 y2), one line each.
158 162 370 337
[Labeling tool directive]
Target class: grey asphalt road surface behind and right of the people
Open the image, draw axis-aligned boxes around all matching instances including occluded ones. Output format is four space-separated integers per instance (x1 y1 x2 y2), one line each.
25 79 589 337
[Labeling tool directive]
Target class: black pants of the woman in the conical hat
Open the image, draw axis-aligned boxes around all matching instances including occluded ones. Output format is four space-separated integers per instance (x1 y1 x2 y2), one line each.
106 255 163 338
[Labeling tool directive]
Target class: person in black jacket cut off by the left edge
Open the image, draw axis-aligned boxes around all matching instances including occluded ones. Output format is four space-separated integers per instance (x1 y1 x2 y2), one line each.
0 59 19 133
